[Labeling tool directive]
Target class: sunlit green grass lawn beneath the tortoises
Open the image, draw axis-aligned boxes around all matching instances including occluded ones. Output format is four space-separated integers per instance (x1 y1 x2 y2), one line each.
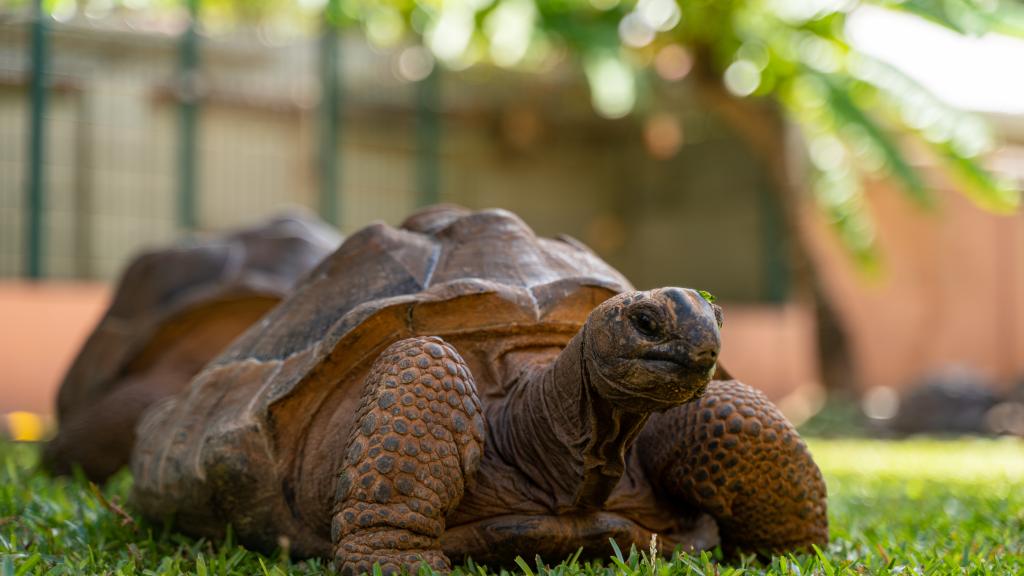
0 440 1024 576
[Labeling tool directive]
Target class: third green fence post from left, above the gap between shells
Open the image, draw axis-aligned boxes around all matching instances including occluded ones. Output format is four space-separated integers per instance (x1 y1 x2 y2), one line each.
317 0 341 225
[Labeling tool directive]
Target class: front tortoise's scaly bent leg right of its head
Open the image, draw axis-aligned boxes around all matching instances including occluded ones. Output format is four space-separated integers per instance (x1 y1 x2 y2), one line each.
637 380 828 551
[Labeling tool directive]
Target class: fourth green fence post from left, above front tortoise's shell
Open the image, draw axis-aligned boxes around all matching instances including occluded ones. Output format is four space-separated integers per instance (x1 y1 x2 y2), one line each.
416 64 441 206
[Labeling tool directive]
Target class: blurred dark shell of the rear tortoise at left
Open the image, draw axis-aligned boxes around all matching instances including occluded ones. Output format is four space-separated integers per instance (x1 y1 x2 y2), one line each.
57 210 341 420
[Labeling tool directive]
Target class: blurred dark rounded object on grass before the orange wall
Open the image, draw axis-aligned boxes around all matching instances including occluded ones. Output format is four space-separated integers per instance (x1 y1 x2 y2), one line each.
889 366 999 435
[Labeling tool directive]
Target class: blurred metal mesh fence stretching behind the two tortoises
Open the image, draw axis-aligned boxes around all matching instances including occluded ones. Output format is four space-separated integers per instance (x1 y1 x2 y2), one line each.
0 4 787 301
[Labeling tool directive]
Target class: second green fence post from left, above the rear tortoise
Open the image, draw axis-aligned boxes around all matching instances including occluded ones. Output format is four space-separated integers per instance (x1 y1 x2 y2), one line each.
178 0 200 231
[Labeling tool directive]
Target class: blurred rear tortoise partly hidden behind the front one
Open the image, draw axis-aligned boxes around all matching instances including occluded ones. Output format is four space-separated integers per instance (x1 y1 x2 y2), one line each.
43 215 341 482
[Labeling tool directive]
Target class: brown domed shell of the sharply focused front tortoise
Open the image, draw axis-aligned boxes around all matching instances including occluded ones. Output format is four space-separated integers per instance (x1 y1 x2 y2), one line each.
133 206 632 556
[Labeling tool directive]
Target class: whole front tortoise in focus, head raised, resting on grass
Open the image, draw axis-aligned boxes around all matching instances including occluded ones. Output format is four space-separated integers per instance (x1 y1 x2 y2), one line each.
132 206 827 573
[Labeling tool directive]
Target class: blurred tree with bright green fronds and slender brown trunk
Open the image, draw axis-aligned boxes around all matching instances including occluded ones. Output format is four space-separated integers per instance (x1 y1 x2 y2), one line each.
331 0 1024 389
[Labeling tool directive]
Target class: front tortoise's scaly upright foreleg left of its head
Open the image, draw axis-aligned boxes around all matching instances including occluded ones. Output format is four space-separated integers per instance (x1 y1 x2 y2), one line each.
331 337 484 574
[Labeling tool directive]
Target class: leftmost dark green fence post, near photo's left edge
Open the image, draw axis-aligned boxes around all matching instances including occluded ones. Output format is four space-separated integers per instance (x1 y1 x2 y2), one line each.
25 0 48 279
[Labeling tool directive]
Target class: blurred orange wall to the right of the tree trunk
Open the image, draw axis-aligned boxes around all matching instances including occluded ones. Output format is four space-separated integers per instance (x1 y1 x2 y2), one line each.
804 182 1024 388
